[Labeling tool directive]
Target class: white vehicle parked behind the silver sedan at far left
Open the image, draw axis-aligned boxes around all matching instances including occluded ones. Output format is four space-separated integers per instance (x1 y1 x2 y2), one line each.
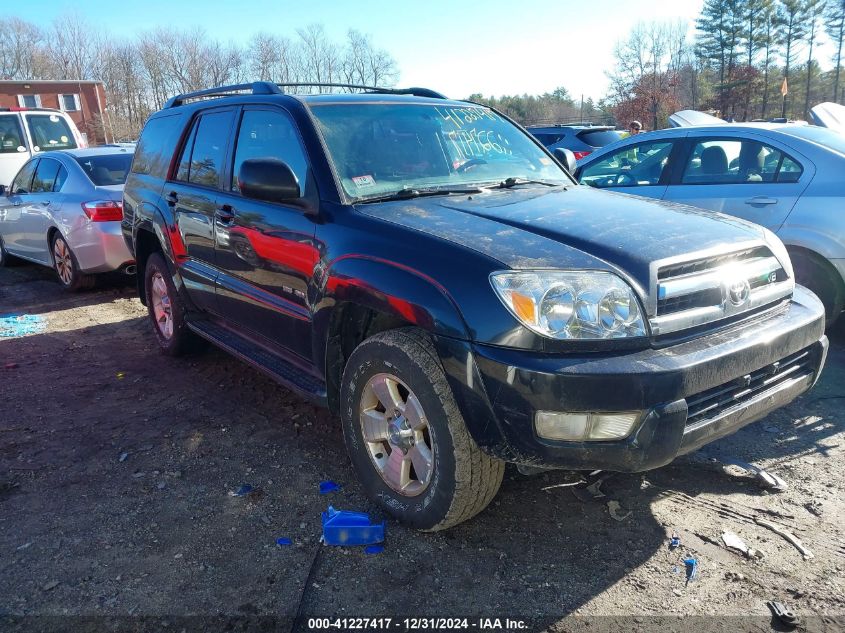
0 108 88 187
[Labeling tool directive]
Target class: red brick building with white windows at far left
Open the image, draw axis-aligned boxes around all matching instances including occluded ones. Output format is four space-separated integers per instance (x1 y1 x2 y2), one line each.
0 79 112 145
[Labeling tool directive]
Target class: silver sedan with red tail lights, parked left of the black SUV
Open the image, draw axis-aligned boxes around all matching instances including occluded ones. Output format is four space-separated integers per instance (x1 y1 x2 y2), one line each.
0 147 135 290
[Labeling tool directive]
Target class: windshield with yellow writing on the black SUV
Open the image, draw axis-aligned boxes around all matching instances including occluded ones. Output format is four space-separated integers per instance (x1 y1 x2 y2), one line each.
310 103 572 199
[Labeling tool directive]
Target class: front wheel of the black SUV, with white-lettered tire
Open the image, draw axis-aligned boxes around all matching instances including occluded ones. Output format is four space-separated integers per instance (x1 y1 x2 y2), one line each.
341 328 504 532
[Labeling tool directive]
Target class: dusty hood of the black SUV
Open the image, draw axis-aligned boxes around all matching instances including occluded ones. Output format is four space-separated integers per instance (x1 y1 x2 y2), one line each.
356 186 765 288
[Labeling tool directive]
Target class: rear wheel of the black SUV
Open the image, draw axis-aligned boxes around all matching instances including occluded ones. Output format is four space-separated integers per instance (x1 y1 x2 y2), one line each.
144 253 197 356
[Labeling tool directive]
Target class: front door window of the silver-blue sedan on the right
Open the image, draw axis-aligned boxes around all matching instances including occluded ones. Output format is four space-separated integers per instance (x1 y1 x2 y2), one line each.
580 141 672 188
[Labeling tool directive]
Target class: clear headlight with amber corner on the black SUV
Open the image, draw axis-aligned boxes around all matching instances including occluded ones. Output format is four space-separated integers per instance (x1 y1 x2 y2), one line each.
490 270 646 340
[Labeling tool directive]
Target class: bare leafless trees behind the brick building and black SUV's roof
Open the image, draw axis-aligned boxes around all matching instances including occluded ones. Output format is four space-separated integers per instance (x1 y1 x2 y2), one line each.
0 14 399 140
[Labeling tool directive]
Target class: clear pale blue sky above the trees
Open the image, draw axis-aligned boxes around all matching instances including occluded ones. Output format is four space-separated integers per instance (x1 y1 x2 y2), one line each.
8 0 792 99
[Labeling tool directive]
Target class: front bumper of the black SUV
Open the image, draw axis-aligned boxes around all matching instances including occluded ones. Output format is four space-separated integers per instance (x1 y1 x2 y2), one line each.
438 287 827 472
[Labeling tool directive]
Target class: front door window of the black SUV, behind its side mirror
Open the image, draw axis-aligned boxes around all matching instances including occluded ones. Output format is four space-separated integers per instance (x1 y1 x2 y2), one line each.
232 110 308 193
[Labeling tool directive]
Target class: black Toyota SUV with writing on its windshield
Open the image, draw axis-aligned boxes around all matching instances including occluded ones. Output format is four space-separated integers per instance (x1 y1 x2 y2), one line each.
123 83 827 530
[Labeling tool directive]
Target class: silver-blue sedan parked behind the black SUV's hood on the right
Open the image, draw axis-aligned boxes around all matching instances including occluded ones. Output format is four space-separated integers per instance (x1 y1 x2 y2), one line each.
575 123 845 325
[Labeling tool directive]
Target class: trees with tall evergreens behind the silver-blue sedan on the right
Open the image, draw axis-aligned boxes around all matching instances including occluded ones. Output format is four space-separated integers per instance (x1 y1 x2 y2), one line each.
602 0 845 128
